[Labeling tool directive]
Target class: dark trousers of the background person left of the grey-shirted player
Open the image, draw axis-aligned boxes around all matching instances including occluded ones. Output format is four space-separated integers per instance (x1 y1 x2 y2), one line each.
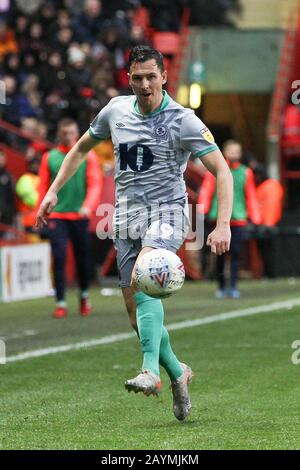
48 219 90 301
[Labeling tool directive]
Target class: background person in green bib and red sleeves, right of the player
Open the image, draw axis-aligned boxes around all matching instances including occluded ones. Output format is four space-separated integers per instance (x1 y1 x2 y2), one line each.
198 140 261 299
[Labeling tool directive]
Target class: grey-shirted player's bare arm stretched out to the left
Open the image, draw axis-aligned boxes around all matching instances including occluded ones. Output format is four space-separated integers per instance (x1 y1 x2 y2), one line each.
36 131 98 228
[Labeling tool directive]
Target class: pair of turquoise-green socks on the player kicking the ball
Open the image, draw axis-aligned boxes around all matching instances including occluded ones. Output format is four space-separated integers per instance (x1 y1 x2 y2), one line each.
134 292 182 381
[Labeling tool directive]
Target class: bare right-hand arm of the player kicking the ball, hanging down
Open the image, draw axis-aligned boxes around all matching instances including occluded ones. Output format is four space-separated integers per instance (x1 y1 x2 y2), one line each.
202 150 233 255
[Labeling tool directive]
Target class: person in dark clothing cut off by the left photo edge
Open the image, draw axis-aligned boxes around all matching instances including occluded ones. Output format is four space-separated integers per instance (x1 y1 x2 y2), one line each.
0 150 15 236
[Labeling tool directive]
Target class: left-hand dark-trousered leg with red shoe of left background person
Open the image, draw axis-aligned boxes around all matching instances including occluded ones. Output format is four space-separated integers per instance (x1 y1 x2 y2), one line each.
48 219 68 318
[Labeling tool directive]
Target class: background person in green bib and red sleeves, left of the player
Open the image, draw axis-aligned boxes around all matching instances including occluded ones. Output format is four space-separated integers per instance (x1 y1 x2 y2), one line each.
39 119 101 318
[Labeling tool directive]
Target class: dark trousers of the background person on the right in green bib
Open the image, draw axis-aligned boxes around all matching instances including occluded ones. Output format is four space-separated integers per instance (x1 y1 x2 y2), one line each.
217 226 245 290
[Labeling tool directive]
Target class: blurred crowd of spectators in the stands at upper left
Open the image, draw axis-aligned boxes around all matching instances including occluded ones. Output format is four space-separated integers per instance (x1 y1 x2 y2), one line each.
0 0 237 141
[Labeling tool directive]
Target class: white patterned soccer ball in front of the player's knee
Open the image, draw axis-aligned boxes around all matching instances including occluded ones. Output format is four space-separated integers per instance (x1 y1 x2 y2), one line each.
135 248 185 299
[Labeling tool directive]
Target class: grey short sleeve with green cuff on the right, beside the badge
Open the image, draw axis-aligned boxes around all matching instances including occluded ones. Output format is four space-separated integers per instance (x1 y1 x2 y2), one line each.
180 110 219 158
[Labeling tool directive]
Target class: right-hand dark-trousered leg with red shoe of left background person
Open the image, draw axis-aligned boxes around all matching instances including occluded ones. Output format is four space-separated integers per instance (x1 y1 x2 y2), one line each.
68 219 92 316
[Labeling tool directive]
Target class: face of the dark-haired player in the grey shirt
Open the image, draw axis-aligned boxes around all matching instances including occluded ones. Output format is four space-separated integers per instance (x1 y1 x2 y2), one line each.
129 59 167 113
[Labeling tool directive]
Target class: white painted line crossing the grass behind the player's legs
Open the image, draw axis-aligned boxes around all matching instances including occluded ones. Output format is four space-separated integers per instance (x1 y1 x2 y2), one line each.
6 298 300 363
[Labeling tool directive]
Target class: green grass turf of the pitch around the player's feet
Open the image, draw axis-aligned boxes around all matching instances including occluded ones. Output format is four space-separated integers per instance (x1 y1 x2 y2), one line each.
0 280 300 450
